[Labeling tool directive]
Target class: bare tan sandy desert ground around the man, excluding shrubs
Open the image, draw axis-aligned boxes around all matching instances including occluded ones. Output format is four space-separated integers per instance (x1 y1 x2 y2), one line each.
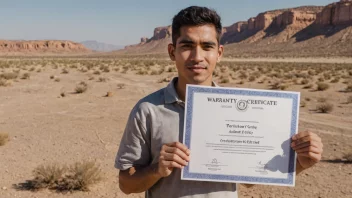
0 64 352 198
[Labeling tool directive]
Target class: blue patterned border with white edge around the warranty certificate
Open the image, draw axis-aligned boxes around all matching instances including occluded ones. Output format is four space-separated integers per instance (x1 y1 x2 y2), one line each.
181 85 300 186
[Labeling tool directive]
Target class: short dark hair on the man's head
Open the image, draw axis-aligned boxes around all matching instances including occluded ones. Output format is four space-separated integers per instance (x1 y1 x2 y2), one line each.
172 6 222 46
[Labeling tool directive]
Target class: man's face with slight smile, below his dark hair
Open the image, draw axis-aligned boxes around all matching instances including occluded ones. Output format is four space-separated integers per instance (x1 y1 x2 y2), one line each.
169 25 223 85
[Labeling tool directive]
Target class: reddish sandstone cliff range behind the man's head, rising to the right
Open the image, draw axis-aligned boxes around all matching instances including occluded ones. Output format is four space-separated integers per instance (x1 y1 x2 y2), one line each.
117 0 352 56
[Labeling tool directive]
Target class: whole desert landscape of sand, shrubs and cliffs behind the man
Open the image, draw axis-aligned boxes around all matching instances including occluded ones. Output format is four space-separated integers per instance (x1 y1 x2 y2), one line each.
0 0 352 198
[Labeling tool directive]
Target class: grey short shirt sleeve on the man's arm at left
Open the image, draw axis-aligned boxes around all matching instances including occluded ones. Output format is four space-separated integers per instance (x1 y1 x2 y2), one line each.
115 107 151 170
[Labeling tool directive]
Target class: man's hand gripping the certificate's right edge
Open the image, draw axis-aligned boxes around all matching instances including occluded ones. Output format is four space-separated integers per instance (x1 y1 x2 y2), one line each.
291 131 323 169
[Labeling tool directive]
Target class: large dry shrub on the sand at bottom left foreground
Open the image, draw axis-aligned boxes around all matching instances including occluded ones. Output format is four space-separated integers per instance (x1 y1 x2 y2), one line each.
14 161 102 192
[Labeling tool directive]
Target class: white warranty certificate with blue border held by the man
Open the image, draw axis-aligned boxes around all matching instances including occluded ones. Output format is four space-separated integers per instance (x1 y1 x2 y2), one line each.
181 85 300 186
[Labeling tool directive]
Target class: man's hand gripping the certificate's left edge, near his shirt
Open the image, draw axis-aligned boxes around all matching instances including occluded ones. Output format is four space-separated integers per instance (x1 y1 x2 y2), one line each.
157 142 190 177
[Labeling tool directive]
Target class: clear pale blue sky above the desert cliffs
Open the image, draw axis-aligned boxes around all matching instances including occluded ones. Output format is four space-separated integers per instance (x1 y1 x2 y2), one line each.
0 0 337 45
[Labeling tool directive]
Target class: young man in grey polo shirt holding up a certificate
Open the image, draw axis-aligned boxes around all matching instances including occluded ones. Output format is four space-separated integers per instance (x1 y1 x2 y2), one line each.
115 6 322 198
